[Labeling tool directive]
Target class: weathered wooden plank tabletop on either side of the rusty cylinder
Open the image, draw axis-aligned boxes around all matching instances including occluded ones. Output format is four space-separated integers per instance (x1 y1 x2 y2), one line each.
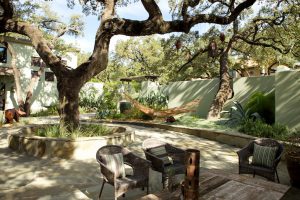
139 170 290 200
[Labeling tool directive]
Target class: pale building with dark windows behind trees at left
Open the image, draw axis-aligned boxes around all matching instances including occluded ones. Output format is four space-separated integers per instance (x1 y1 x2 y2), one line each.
0 36 77 113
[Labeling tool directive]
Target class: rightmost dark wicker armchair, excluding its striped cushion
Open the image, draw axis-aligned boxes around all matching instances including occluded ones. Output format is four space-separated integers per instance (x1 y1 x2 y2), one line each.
237 138 283 183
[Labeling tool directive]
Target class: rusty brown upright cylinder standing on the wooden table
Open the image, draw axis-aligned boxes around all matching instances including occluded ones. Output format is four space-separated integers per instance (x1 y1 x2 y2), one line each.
183 149 200 200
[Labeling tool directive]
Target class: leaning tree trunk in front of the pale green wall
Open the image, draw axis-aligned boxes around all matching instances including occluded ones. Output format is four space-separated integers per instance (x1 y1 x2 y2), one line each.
207 51 233 119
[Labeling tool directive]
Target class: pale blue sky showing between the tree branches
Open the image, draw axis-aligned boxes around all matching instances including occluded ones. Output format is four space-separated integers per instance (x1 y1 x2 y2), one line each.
47 0 209 52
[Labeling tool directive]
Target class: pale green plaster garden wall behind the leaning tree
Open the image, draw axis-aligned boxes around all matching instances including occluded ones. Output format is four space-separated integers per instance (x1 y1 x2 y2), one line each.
142 71 300 129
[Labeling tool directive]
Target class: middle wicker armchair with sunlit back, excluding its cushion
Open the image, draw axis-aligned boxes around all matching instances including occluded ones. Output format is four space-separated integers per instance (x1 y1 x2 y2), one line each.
142 138 185 188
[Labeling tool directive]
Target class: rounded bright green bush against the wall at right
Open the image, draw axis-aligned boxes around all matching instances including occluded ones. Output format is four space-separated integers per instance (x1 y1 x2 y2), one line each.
245 91 275 124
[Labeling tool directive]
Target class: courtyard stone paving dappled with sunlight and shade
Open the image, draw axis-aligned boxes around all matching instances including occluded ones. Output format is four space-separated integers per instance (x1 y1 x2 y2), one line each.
0 115 288 200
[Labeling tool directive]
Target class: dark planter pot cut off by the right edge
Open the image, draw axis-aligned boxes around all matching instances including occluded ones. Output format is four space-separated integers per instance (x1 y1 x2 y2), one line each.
285 131 300 188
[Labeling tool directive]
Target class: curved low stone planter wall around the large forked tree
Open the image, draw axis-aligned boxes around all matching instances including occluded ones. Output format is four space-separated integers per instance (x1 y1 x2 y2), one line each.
8 125 135 159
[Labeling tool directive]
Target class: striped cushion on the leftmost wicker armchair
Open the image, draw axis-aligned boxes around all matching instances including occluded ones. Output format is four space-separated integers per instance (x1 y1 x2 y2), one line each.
101 153 125 178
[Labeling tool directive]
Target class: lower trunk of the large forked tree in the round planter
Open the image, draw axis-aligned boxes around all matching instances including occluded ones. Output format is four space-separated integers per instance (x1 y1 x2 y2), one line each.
57 78 83 132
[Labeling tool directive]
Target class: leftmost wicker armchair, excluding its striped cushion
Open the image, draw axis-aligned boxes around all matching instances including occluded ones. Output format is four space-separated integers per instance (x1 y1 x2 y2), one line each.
96 145 151 199
